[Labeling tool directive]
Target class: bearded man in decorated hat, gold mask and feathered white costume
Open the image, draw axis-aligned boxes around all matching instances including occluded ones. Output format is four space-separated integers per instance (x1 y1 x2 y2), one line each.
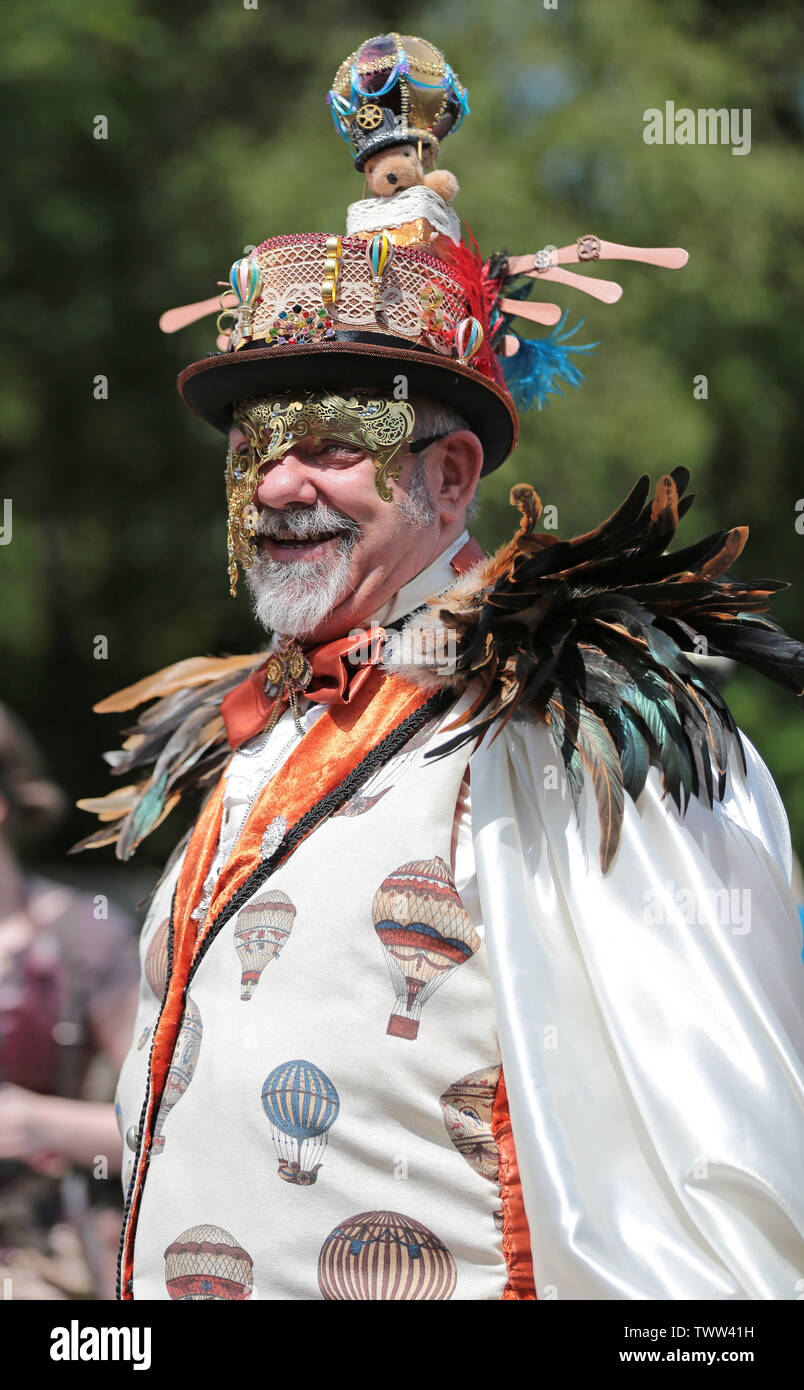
83 36 803 1301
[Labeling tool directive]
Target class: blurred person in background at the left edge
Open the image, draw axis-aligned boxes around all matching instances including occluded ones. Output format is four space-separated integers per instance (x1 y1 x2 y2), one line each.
0 705 138 1300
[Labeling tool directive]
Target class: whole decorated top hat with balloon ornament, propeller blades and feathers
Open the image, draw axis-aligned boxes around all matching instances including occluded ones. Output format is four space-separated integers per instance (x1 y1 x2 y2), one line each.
160 33 687 474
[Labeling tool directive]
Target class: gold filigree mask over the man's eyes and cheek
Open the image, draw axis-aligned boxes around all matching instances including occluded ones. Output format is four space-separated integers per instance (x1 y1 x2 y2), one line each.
227 391 416 596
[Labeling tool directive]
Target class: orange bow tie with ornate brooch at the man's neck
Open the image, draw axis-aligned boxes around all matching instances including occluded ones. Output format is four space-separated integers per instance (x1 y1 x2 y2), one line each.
221 627 385 748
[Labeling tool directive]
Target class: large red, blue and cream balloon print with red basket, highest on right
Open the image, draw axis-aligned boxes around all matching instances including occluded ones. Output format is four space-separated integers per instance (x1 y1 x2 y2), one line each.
373 856 480 1038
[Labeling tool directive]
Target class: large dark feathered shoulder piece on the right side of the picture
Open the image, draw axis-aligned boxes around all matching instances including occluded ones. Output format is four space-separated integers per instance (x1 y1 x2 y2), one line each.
401 468 804 872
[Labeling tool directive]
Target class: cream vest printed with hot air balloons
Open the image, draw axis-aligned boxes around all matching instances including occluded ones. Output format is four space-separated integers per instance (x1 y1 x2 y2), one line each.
118 706 508 1300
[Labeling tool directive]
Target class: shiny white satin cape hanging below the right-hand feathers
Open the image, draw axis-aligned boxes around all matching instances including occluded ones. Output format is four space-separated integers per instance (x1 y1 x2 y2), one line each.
470 723 804 1300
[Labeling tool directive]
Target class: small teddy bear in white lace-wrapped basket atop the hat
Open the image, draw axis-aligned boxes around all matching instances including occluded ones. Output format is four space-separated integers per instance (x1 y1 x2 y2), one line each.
340 145 460 250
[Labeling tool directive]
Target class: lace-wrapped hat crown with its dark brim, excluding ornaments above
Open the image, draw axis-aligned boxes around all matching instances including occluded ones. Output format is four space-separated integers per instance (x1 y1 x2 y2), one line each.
178 232 517 471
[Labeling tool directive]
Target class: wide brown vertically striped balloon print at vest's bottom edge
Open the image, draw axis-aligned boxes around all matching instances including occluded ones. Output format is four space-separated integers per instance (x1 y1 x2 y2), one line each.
319 1212 458 1302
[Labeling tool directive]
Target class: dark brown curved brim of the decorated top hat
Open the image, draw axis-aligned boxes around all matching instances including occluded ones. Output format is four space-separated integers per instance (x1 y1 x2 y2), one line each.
178 331 519 474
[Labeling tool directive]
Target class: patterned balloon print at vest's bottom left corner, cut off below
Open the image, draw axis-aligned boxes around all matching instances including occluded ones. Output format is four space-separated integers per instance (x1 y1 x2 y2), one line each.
164 1226 255 1302
